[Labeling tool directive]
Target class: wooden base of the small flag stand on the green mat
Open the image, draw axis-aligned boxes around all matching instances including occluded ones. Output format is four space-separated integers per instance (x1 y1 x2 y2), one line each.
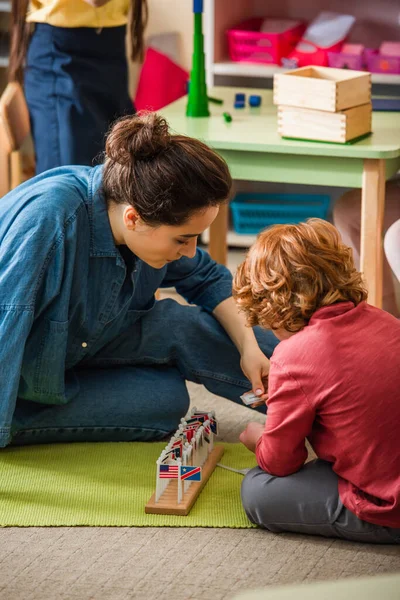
145 446 224 517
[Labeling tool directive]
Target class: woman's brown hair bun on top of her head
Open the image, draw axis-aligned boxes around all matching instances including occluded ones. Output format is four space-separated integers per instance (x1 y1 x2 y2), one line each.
106 113 171 166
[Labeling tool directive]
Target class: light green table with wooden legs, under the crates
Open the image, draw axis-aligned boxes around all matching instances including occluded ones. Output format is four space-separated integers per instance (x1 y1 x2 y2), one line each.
161 87 400 307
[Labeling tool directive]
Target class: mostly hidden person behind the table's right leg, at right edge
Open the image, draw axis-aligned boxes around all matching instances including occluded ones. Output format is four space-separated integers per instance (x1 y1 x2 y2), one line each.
333 184 400 317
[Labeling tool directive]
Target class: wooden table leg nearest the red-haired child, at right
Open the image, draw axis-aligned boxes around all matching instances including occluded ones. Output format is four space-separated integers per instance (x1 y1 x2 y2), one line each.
361 158 386 308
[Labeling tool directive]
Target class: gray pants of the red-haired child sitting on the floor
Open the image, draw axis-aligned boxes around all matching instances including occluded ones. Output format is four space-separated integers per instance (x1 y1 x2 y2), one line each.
242 460 400 544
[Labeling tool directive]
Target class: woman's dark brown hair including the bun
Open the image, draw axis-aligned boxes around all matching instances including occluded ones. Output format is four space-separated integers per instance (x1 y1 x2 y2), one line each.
103 113 232 226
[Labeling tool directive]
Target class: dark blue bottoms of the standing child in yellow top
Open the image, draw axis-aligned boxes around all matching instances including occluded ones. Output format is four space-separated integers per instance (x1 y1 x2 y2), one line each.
24 23 135 174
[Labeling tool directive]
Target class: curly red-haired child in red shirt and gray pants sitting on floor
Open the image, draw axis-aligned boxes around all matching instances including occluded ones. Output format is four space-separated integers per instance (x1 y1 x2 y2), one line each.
234 219 400 544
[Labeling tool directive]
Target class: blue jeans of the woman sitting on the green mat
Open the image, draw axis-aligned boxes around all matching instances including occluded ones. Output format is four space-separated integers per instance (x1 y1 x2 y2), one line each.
12 299 278 445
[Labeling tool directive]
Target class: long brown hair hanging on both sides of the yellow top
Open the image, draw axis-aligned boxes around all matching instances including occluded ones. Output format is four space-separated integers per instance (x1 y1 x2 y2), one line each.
8 0 149 82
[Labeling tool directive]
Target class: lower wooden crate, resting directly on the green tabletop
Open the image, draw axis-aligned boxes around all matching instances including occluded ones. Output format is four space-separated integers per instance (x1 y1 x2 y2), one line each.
278 103 372 143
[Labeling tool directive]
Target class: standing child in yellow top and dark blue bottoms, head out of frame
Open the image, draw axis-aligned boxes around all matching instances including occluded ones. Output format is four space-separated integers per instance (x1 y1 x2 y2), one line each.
9 0 148 174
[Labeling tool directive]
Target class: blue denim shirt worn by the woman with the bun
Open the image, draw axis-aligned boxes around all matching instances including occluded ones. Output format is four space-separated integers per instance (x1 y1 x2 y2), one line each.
0 166 232 447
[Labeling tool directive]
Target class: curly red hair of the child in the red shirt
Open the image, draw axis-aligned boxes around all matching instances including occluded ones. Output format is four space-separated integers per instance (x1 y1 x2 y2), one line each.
233 219 367 332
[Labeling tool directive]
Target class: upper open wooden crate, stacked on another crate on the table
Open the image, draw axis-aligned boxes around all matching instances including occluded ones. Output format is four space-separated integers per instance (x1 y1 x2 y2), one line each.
274 67 371 112
